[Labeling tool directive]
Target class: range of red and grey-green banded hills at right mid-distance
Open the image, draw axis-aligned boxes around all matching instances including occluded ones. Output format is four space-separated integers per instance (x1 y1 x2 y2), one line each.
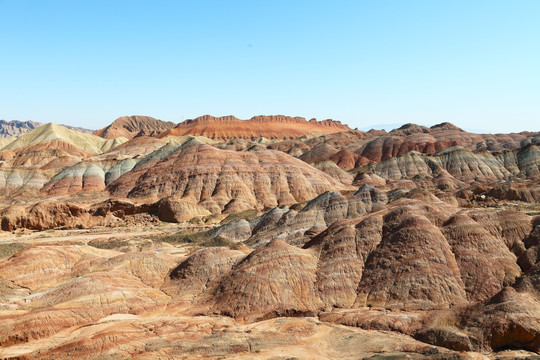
267 123 540 188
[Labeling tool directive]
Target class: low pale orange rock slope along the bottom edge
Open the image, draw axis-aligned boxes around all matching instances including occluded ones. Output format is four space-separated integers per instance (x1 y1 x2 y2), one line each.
0 314 462 360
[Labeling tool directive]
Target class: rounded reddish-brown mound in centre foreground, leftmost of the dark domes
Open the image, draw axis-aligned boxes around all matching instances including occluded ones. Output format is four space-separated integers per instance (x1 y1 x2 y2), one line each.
207 240 323 318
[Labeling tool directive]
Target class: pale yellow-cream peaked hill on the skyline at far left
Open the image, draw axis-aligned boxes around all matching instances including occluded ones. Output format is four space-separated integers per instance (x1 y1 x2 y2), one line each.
2 123 127 154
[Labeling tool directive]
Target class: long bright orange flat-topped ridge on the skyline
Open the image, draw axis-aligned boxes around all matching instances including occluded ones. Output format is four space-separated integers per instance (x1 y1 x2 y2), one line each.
159 115 351 140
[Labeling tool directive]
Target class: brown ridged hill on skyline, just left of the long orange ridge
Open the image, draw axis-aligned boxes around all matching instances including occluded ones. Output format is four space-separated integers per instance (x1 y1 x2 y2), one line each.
94 115 176 139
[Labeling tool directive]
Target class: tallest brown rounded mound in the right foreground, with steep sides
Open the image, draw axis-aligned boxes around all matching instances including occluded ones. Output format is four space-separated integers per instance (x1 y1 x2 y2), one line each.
356 202 465 309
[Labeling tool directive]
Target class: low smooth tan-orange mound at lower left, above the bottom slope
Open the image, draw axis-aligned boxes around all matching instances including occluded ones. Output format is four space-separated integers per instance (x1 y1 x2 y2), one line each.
0 271 168 347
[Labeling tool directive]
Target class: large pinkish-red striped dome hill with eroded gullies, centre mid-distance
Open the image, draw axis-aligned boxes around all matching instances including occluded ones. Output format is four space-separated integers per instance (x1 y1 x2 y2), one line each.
108 140 346 213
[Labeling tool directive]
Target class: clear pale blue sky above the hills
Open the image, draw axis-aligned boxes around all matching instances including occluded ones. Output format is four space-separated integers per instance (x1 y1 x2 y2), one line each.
0 0 540 132
